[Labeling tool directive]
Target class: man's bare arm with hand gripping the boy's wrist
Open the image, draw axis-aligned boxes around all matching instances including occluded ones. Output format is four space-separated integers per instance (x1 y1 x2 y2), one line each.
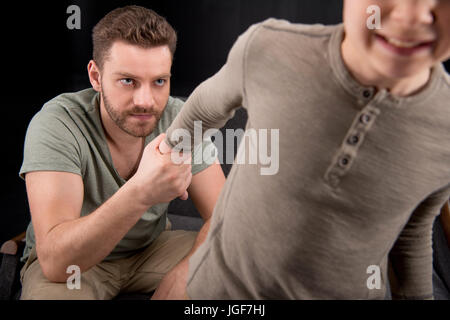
25 135 192 282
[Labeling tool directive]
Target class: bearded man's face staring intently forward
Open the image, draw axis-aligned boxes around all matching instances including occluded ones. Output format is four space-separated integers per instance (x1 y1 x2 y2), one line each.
101 41 172 137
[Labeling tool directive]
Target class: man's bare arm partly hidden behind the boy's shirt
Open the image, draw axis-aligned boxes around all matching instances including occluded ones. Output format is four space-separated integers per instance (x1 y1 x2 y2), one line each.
152 161 225 300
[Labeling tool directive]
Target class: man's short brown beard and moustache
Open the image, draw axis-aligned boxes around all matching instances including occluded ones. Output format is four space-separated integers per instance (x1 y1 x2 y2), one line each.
101 88 161 138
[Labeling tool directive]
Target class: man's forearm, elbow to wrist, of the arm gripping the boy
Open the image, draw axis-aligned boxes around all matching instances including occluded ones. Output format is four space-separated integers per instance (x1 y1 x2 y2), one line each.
39 180 148 282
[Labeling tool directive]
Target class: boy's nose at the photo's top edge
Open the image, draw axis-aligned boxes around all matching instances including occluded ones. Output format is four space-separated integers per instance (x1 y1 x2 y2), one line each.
391 0 436 28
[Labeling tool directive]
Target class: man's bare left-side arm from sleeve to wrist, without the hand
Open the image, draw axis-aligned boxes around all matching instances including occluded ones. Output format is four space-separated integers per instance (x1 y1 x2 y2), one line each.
25 171 146 282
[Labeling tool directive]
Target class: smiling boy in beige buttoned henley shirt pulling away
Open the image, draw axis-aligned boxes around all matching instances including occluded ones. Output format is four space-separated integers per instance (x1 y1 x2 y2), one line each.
160 0 450 299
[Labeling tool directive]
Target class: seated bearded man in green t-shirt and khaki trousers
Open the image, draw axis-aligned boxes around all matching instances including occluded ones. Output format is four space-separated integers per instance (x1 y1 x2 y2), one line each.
20 6 225 299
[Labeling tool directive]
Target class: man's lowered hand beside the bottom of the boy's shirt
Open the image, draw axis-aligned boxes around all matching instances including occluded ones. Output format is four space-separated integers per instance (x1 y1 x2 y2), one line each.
151 257 189 300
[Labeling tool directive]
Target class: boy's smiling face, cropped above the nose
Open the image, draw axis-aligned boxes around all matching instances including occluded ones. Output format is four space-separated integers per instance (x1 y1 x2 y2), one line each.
344 0 450 78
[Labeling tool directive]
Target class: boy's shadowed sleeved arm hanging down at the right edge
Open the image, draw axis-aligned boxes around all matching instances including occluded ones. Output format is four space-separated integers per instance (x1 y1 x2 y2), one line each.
389 186 450 299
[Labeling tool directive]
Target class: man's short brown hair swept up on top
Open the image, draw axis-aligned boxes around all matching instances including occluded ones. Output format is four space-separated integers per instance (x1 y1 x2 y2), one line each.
92 6 177 70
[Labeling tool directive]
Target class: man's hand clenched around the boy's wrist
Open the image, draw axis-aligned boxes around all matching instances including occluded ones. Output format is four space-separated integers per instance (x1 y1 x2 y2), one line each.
129 134 192 206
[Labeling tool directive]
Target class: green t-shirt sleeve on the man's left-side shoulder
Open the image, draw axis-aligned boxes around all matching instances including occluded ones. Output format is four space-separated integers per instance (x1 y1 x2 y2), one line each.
19 105 82 179
